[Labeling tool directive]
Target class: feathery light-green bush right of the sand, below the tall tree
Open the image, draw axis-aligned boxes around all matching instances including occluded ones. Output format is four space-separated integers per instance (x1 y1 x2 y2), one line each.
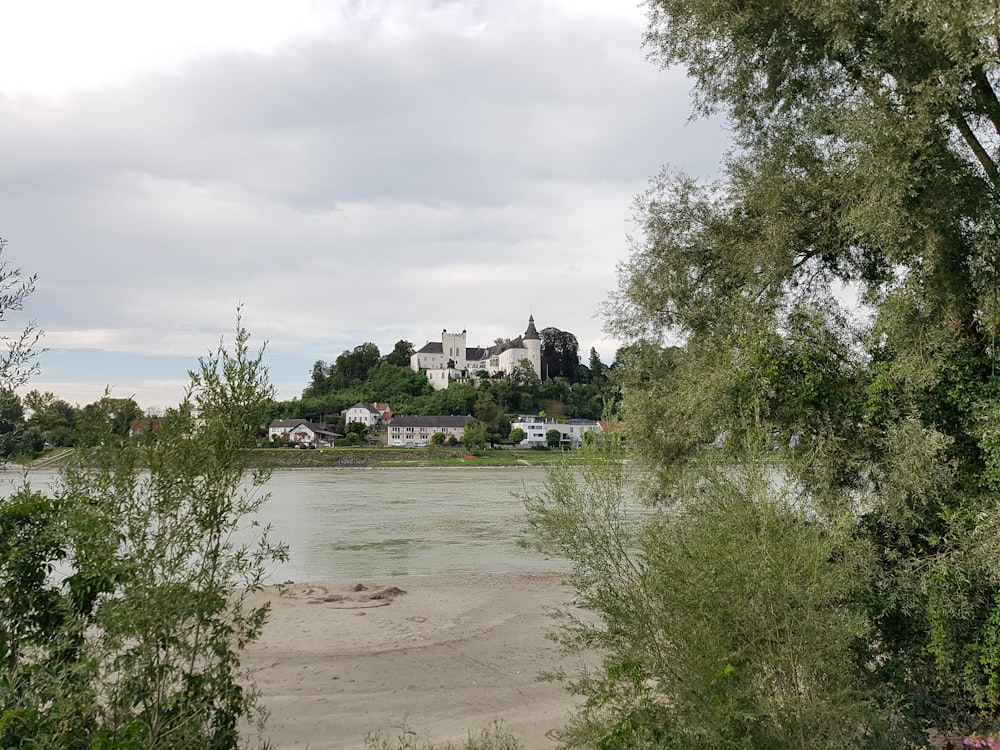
524 439 890 750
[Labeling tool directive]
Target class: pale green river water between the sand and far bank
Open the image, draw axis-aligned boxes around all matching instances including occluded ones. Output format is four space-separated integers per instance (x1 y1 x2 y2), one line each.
0 469 567 581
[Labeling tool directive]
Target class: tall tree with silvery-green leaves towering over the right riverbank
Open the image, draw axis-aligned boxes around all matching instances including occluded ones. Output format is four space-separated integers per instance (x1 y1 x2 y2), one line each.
532 0 1000 747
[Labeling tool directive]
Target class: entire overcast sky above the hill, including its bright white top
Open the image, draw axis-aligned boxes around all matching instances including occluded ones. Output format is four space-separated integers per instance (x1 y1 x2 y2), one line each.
0 0 727 408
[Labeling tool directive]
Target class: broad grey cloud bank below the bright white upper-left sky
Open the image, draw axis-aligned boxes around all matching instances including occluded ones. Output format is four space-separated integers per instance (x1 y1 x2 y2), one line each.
0 3 725 412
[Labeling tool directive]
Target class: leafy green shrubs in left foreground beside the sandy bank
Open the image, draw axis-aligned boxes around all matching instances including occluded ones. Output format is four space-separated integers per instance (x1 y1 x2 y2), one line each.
0 312 287 749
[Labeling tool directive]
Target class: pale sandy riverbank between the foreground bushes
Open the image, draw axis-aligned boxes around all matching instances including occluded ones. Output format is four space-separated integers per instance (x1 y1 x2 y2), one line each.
244 573 575 750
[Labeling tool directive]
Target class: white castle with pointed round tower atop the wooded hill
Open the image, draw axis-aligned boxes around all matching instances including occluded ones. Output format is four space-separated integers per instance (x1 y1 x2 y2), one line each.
410 316 542 390
